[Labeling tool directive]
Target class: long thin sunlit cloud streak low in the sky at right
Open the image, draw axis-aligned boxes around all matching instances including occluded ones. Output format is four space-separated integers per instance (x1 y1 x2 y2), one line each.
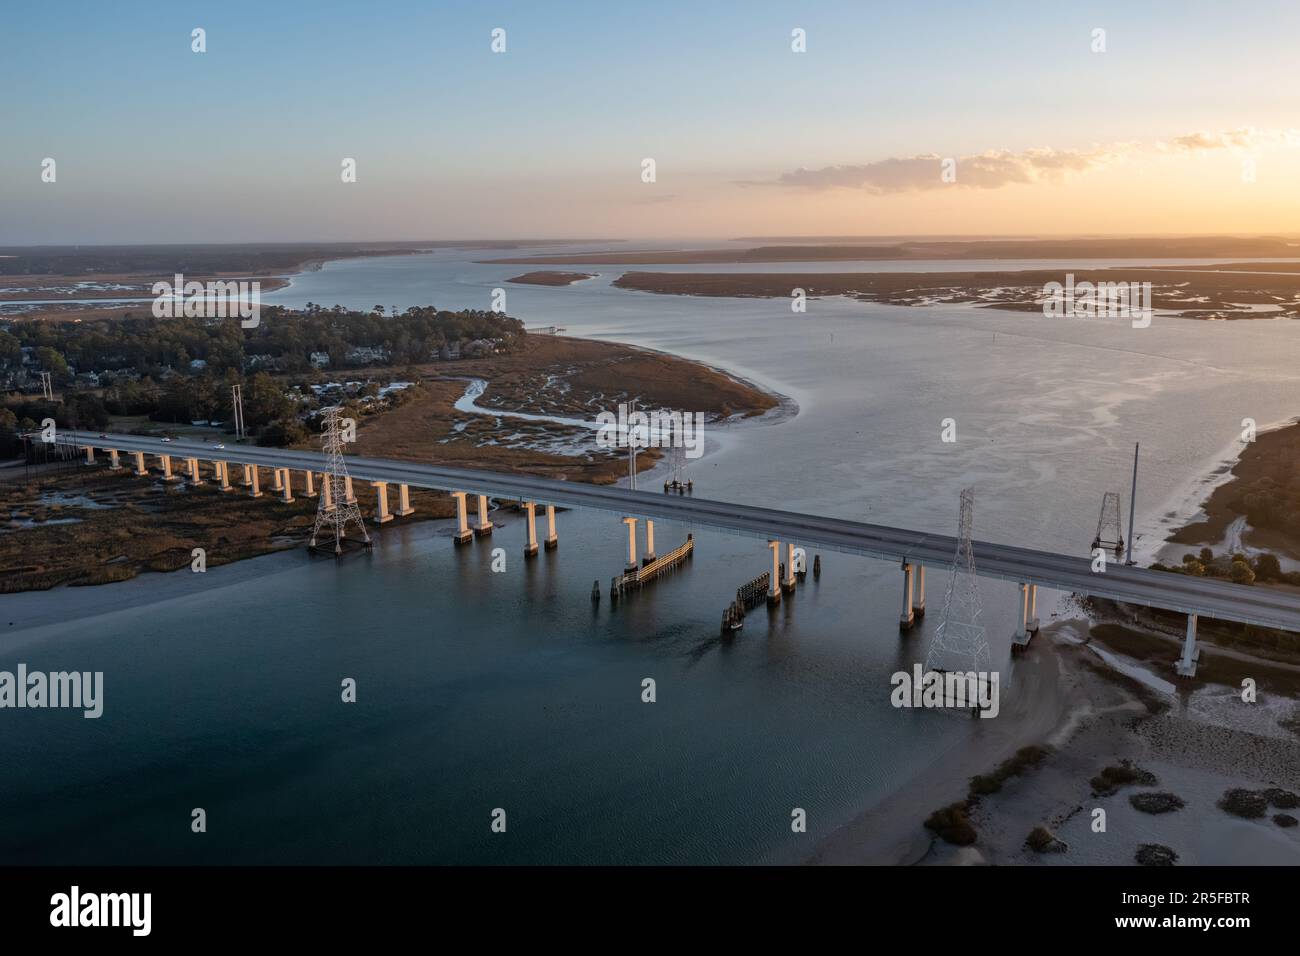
764 127 1300 195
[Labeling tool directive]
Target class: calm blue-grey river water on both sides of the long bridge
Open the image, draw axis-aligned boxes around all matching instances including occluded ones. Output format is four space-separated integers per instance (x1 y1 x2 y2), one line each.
0 243 1300 862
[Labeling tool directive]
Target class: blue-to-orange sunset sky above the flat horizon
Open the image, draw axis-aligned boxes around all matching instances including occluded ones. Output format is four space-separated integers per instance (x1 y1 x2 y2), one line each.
0 0 1300 245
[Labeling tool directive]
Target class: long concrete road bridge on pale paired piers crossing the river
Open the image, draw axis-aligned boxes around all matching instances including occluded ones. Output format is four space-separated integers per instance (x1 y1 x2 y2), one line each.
50 431 1300 675
